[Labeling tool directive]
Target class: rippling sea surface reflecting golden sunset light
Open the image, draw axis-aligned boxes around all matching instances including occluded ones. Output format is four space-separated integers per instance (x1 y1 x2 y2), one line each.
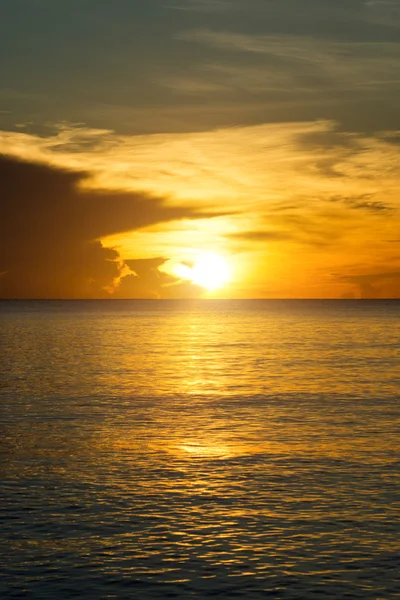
0 300 400 600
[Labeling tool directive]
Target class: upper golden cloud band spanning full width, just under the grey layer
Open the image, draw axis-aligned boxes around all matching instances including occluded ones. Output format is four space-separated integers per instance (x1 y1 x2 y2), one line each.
0 121 400 214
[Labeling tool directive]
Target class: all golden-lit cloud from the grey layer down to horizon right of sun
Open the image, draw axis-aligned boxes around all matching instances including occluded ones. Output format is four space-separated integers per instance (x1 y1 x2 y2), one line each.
0 121 400 296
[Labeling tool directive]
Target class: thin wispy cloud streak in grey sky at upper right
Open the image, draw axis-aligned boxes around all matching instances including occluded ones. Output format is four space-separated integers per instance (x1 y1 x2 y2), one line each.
178 29 400 91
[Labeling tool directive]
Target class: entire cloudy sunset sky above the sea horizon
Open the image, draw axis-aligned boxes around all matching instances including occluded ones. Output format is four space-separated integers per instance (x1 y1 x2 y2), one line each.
0 0 400 298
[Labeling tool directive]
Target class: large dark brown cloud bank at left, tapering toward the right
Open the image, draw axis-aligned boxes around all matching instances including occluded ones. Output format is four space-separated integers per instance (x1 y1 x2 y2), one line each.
0 156 217 298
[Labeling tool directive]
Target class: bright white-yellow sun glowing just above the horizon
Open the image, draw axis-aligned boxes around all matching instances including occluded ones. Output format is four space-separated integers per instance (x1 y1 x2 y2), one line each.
175 252 230 292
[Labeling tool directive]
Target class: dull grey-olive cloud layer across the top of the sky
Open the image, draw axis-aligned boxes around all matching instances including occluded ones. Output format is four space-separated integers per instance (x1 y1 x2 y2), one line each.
0 0 399 134
